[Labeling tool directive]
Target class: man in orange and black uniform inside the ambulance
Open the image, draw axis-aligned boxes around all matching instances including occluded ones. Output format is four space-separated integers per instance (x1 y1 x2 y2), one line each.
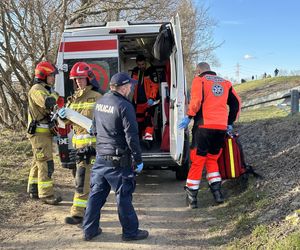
131 55 159 147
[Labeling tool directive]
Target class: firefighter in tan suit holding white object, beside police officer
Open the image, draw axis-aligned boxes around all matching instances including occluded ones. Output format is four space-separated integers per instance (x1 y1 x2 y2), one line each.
58 62 101 225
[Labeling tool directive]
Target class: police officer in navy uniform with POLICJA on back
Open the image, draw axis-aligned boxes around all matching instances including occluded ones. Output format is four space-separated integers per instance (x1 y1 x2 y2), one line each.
82 72 148 241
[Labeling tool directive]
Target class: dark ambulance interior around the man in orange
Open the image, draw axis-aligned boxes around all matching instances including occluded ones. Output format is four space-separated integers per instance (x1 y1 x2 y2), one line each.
119 34 170 154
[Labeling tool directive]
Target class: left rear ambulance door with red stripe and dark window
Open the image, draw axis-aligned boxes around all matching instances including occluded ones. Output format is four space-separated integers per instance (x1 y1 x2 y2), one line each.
55 34 119 97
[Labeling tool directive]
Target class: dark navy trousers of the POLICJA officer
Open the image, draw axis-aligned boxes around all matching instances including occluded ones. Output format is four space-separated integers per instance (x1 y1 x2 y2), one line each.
82 156 139 237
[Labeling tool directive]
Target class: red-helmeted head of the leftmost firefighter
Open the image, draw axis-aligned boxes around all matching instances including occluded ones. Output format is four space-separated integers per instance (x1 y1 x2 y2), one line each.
34 61 58 85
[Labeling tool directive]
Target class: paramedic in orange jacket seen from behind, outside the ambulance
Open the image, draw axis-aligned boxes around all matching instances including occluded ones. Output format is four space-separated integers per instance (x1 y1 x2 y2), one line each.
178 62 241 208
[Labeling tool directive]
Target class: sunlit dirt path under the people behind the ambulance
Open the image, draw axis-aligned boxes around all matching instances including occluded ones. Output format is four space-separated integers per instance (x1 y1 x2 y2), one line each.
0 169 228 249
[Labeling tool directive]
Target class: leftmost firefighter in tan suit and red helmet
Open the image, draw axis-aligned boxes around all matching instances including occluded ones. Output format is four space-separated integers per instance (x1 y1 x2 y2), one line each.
27 61 62 205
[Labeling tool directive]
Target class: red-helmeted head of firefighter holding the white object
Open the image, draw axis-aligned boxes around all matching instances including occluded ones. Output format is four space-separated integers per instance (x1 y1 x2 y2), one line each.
70 62 99 89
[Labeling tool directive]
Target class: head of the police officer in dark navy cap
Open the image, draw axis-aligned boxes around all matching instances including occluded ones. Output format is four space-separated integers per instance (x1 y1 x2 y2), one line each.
110 72 137 97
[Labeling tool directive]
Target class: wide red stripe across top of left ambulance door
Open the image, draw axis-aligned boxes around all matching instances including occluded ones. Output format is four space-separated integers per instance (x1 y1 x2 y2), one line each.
59 40 117 52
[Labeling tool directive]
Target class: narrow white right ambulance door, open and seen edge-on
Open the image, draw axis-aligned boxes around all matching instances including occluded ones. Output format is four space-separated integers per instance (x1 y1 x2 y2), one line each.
170 14 186 165
